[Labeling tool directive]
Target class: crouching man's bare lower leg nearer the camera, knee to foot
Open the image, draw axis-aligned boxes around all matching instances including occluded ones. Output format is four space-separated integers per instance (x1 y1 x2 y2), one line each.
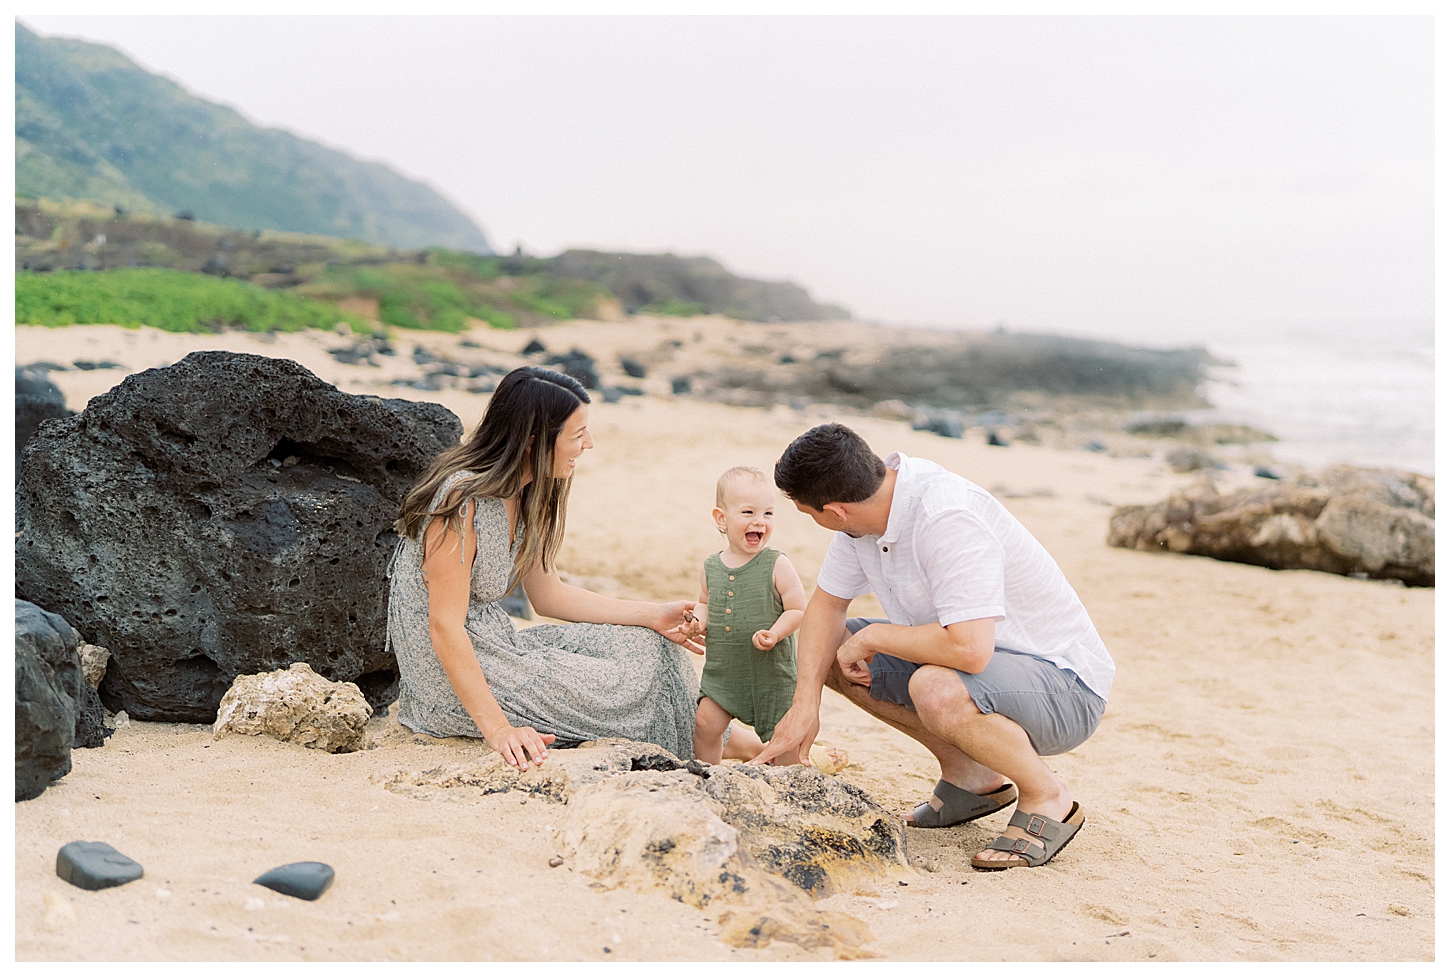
903 665 1073 861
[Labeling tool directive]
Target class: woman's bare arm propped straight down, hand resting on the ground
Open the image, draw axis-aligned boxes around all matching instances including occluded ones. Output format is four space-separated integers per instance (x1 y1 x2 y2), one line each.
423 500 554 770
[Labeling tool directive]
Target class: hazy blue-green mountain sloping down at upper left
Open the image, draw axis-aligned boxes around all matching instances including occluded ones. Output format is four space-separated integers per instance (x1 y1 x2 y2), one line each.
15 23 493 254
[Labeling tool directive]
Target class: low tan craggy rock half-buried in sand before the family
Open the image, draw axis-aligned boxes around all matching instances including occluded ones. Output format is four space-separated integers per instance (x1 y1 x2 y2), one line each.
376 739 911 957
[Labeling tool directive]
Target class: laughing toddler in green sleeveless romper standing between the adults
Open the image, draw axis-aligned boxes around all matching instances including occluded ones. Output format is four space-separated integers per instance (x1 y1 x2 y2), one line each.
692 468 806 764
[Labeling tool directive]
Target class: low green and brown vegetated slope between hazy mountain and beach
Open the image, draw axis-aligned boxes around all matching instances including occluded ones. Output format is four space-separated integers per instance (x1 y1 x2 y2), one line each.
15 200 848 332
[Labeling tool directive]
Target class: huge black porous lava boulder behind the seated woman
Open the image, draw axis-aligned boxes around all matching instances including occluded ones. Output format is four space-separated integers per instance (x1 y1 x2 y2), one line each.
16 351 463 723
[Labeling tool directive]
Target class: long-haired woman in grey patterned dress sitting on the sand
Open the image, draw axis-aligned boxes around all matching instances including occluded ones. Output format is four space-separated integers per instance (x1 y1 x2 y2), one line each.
387 360 699 770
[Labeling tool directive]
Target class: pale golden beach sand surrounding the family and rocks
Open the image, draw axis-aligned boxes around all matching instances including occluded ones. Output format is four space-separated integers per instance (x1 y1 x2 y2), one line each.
15 320 1434 961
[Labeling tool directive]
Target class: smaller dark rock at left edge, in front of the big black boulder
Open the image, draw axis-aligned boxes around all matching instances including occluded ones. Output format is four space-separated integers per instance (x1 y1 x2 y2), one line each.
15 600 109 800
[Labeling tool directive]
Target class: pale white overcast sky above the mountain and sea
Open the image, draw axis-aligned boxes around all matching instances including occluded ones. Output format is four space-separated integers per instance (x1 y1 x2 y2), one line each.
23 16 1434 339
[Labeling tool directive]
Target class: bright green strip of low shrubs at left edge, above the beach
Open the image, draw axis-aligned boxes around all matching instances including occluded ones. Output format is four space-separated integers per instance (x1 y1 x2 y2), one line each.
15 268 367 332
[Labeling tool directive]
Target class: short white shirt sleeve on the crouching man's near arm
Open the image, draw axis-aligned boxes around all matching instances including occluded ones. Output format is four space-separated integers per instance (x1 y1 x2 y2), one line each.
916 509 1006 628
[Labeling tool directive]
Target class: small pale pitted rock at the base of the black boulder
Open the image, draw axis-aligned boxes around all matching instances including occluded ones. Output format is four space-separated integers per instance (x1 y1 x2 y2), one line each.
212 661 373 754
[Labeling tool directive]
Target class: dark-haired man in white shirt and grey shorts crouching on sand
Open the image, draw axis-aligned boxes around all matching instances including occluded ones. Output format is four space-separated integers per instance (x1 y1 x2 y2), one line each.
751 423 1114 870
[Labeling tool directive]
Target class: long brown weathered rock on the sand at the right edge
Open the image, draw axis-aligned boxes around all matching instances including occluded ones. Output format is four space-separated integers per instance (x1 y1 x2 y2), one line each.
1108 465 1436 587
